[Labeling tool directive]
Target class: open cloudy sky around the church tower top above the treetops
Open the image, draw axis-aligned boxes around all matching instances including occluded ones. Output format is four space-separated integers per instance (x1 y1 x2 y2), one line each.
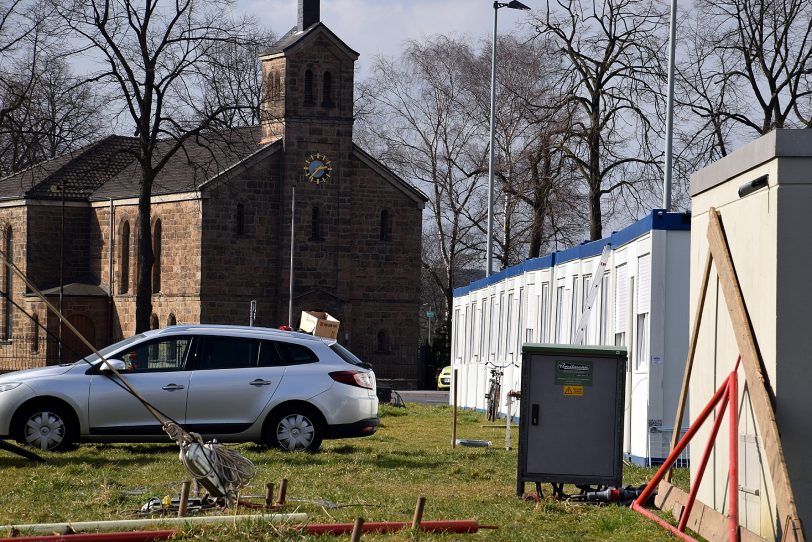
238 0 542 78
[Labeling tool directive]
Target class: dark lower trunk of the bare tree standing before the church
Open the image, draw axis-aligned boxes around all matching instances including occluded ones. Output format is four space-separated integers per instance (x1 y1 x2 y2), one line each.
135 169 154 333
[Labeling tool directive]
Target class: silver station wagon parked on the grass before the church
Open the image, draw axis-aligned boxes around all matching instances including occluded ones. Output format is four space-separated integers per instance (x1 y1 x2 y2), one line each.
0 325 379 451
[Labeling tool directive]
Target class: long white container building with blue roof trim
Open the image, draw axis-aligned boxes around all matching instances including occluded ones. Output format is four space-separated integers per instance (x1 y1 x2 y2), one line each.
449 210 691 465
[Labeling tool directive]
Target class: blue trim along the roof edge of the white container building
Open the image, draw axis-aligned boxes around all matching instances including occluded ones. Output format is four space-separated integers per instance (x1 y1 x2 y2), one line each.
454 209 691 297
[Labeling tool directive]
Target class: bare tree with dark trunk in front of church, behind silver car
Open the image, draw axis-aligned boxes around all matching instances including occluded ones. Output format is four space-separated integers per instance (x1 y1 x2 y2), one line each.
55 0 254 332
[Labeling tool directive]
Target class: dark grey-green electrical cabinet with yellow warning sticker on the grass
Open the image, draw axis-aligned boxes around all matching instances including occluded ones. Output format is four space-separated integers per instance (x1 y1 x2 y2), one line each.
516 344 626 496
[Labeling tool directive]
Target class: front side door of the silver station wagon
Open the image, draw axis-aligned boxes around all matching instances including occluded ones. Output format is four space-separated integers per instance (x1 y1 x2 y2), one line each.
88 335 195 437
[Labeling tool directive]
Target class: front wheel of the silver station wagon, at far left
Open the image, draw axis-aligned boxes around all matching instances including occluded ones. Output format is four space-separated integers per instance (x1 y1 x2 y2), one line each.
12 403 76 452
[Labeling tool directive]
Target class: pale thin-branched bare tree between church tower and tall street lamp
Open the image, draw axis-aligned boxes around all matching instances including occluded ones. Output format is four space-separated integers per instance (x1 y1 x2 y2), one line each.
358 36 487 332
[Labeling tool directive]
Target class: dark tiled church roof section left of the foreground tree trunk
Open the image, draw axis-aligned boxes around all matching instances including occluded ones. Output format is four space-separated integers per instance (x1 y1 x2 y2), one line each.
0 135 138 199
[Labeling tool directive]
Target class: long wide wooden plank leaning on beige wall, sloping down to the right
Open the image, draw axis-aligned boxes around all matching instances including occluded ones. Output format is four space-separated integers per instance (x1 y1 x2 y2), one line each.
708 207 804 542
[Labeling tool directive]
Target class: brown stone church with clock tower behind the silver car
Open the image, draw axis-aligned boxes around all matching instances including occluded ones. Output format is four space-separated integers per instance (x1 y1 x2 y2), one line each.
0 0 427 385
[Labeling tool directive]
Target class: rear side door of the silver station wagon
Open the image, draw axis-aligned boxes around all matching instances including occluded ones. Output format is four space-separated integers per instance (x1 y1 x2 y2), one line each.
186 336 285 435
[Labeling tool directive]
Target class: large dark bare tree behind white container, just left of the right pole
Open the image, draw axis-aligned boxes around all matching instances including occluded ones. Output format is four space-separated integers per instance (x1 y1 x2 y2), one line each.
533 0 665 239
